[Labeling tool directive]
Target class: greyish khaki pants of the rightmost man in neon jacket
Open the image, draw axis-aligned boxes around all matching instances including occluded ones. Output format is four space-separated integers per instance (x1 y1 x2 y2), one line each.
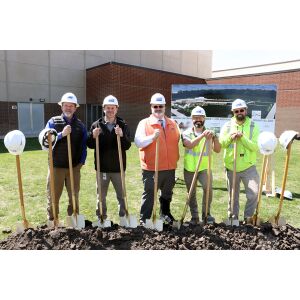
226 166 259 218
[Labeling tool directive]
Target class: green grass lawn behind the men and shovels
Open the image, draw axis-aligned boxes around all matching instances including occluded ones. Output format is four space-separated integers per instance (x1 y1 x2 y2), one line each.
0 139 300 239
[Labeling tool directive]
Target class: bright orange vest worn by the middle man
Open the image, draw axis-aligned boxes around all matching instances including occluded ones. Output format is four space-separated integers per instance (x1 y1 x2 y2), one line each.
139 115 180 171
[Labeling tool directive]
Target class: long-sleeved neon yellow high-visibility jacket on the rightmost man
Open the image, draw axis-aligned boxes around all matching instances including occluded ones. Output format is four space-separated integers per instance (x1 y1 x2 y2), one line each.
220 117 259 172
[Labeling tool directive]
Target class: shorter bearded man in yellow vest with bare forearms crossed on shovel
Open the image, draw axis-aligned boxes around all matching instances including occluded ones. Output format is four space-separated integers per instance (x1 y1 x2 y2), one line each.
182 106 221 225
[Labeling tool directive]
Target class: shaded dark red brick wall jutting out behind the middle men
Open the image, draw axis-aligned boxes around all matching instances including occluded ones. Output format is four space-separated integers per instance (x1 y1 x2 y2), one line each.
86 63 205 137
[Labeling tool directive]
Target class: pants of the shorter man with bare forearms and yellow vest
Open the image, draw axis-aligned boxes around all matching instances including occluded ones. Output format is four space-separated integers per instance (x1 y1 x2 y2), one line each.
184 170 213 219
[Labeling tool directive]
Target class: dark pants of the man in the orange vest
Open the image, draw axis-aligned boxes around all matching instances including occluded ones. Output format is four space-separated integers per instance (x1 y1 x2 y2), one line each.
140 170 175 222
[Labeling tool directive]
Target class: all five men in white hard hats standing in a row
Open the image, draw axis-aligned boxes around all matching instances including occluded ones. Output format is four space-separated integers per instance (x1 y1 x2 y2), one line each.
41 93 259 225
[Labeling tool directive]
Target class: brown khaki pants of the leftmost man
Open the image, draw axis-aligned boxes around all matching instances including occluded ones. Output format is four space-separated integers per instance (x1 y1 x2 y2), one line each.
47 164 82 220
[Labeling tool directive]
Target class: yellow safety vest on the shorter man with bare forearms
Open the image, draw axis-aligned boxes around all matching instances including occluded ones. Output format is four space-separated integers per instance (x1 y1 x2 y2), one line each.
183 128 208 172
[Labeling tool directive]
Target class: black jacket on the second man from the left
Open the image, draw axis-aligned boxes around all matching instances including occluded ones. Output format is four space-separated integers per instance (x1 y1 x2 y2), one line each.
87 117 131 173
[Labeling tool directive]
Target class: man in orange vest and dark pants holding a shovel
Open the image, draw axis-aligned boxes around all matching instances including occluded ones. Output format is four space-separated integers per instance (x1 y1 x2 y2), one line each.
134 93 180 225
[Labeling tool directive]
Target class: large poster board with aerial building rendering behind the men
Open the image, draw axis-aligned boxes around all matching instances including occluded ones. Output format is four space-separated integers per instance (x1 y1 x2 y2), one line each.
171 84 277 134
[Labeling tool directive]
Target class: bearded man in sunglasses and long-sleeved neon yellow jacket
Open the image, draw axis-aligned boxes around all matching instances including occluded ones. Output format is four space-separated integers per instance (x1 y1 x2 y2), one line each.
220 99 259 220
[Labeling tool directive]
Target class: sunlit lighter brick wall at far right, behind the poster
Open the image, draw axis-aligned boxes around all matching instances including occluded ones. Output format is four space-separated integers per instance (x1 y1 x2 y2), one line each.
206 70 300 135
